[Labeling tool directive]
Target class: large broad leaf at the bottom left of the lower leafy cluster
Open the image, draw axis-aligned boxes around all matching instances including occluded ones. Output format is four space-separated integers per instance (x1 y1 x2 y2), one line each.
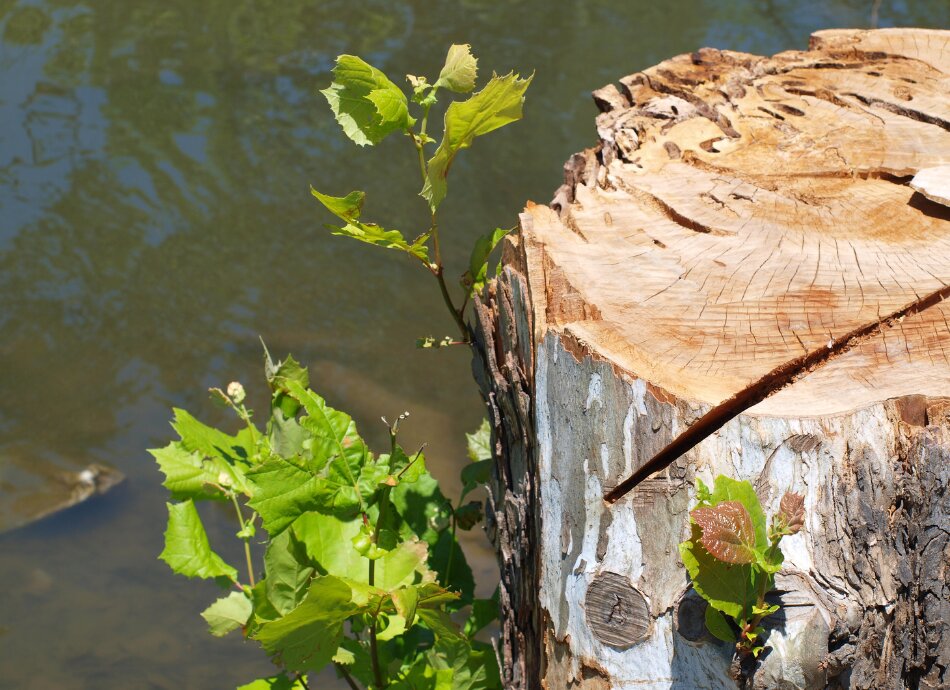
254 576 359 671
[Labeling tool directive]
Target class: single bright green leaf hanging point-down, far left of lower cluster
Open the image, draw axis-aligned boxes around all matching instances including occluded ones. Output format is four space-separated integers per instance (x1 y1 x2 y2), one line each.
159 500 237 580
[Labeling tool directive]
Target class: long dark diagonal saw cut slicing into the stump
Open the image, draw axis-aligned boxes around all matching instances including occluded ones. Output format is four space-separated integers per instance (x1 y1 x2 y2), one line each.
604 285 950 503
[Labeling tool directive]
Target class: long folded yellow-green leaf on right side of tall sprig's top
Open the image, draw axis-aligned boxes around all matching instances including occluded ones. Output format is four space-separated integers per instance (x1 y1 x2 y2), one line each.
421 73 533 212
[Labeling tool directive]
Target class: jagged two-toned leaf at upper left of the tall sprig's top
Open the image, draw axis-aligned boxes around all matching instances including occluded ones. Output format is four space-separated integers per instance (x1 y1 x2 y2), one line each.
320 55 411 146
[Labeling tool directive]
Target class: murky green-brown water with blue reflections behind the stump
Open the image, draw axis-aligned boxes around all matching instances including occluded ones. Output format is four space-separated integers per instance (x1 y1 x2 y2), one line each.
0 0 950 690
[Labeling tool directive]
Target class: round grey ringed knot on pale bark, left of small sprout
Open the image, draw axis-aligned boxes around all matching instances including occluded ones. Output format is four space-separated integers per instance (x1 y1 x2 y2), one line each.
584 572 650 649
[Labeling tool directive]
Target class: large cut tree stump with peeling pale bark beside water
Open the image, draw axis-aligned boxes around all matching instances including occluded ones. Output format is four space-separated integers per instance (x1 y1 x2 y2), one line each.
474 29 950 690
